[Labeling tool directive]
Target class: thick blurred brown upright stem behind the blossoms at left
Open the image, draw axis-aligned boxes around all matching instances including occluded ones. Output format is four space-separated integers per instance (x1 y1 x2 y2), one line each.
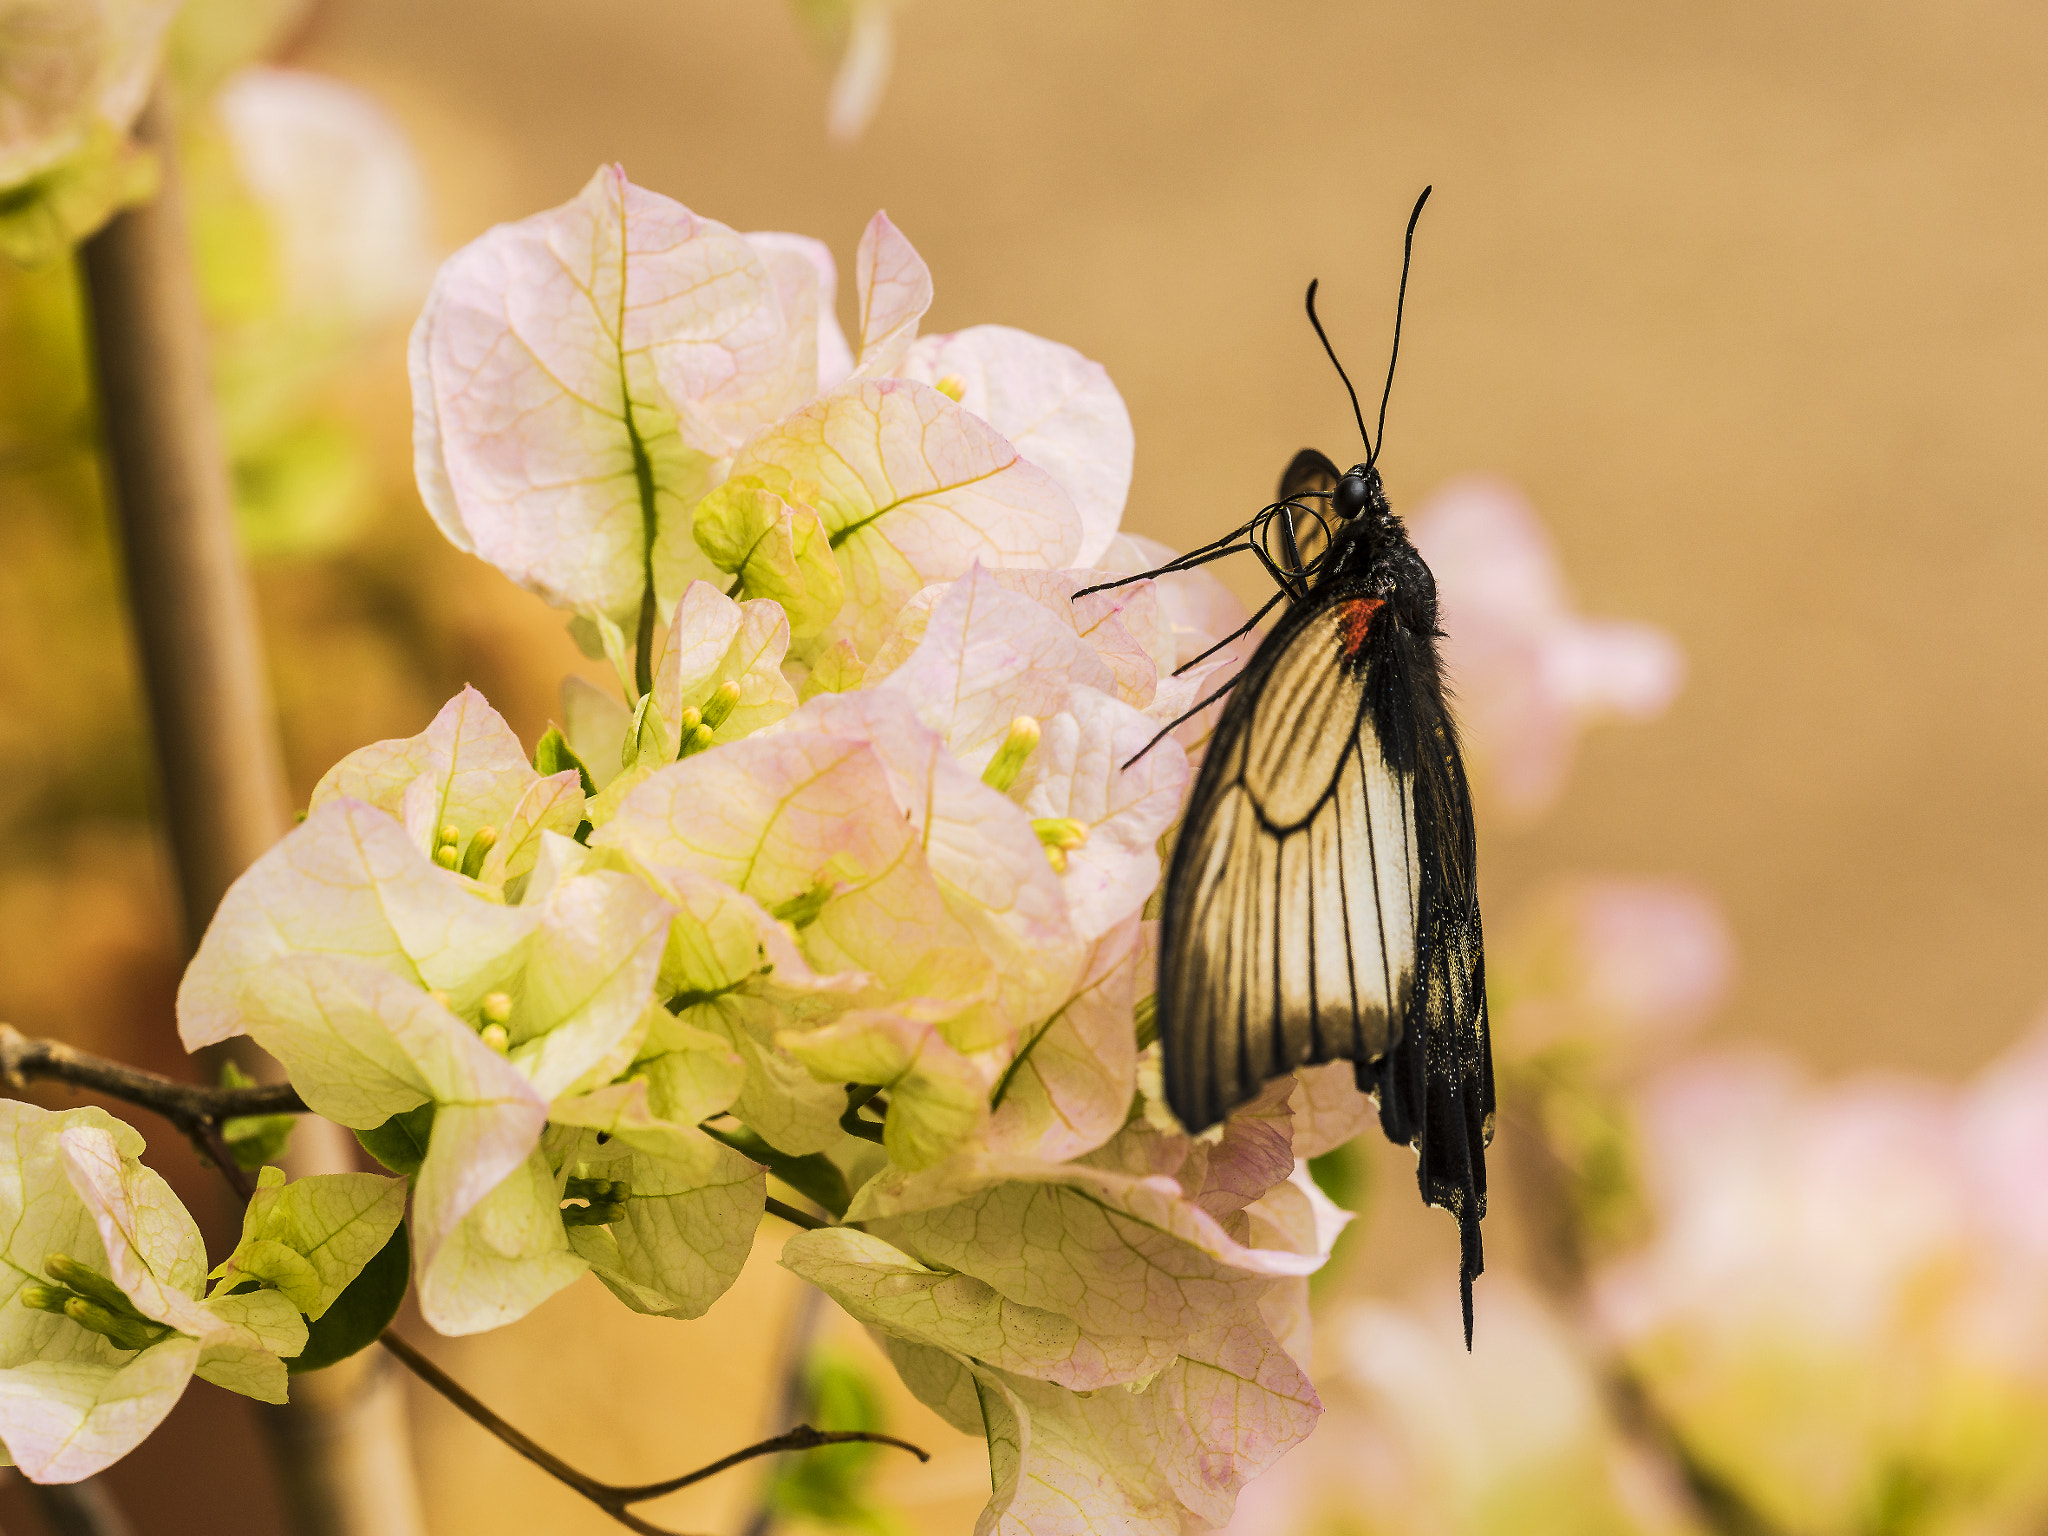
80 92 426 1536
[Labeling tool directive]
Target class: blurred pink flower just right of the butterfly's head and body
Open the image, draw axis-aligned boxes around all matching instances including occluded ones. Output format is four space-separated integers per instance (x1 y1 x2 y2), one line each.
1411 477 1686 815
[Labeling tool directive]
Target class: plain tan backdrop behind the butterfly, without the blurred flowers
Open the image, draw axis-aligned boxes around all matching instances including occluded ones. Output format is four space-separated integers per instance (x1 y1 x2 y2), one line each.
6 0 2048 1536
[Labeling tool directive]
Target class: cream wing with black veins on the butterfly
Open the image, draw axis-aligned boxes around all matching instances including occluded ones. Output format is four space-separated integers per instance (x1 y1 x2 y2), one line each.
1161 598 1419 1128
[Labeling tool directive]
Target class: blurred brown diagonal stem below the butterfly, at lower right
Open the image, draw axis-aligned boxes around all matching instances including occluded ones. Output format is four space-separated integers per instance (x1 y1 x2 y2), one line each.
1495 1092 1782 1536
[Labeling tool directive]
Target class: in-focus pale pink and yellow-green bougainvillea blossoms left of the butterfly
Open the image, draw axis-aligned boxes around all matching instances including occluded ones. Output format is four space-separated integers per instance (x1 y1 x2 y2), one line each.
0 156 1695 1536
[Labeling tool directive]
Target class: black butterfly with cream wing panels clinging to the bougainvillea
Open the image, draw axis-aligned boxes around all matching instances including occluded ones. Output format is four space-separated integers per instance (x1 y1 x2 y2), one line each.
1097 190 1493 1343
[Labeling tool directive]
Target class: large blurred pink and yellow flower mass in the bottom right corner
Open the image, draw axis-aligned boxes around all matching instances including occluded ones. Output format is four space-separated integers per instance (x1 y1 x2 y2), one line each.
1597 1032 2048 1530
